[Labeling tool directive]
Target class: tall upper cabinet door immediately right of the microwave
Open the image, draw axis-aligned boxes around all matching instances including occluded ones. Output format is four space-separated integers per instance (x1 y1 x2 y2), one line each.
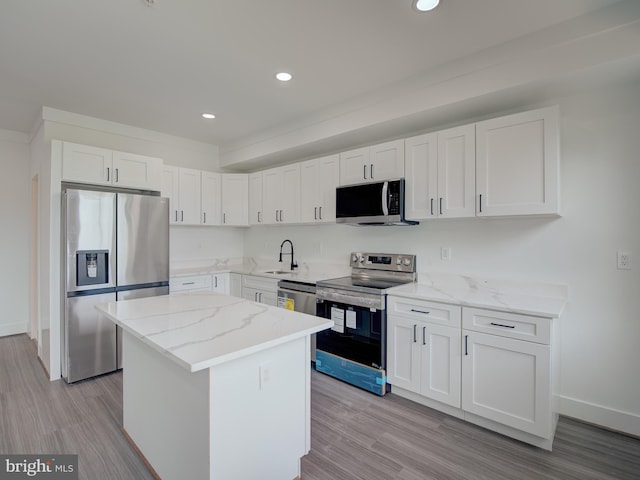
404 133 440 220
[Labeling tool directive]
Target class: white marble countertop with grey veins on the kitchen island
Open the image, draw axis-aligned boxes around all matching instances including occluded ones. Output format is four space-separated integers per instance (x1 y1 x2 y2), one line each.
96 293 333 372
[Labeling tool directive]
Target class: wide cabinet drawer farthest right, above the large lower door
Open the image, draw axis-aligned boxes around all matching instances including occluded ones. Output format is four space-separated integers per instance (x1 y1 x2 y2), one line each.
462 307 551 345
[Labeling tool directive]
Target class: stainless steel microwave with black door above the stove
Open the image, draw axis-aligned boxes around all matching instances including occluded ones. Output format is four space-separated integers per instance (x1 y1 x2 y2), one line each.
336 178 418 225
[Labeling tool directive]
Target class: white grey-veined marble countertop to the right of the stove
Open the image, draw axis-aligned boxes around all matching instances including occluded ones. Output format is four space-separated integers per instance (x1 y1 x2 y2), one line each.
388 273 567 318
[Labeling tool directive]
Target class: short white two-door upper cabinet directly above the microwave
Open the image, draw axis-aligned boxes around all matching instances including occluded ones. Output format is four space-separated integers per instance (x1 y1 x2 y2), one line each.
340 139 404 185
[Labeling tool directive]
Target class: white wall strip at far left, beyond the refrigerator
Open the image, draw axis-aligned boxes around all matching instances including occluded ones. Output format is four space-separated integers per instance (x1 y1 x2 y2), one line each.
0 130 31 336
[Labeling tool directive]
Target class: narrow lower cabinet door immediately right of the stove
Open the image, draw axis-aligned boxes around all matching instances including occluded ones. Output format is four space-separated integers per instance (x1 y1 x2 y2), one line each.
387 315 422 393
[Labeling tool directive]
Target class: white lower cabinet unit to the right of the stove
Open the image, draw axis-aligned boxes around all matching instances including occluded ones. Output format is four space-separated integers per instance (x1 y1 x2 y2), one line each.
387 295 557 450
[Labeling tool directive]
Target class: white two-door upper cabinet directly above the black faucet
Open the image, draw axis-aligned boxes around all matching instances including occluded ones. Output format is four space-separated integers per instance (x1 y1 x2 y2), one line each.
262 163 300 224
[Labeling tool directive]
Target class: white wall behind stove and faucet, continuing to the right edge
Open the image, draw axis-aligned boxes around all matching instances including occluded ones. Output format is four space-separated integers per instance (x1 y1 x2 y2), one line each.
245 82 640 435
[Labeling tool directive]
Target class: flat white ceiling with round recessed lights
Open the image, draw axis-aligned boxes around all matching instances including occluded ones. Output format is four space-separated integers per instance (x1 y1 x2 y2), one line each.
0 0 632 164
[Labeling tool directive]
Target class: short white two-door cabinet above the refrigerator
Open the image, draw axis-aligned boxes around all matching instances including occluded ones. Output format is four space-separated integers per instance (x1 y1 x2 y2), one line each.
62 142 162 191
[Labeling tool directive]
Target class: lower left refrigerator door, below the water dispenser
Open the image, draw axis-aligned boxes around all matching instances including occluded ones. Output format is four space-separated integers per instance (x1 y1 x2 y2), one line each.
62 293 116 383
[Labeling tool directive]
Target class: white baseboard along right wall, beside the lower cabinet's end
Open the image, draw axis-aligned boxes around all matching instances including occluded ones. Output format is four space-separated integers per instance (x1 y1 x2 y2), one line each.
558 396 640 437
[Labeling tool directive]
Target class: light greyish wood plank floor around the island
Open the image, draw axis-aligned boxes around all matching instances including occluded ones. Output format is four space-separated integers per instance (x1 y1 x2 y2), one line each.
0 335 640 480
